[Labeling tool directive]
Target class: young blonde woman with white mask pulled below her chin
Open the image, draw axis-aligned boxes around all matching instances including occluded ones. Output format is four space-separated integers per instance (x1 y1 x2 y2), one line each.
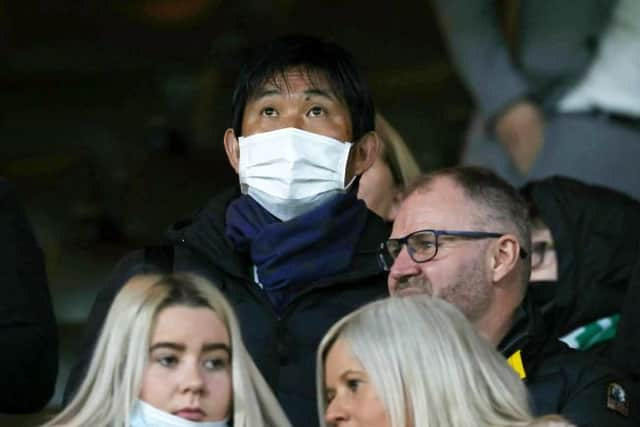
46 274 290 427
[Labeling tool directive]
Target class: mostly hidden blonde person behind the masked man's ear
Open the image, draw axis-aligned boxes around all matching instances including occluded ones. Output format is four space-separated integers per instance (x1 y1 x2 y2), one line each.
358 114 420 221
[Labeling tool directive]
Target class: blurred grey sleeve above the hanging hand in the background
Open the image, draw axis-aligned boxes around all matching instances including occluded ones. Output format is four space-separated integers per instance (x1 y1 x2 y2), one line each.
432 0 530 122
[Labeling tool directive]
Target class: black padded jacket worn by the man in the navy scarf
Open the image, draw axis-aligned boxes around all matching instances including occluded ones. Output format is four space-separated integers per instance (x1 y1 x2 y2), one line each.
65 190 390 426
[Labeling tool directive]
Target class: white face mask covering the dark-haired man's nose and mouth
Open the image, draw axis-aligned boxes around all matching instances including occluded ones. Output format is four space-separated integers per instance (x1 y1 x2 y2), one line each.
239 128 355 221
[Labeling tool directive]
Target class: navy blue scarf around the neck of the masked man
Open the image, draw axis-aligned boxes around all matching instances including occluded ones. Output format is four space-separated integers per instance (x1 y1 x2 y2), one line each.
226 191 367 312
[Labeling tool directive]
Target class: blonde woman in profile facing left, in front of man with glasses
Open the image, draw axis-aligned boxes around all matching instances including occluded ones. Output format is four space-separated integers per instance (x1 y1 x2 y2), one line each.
317 295 569 427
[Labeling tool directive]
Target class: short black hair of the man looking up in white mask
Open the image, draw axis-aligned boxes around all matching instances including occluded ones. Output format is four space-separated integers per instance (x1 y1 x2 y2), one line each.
231 35 375 141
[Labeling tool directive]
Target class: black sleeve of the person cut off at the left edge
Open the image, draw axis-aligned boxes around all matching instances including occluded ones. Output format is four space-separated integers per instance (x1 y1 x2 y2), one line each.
0 179 58 413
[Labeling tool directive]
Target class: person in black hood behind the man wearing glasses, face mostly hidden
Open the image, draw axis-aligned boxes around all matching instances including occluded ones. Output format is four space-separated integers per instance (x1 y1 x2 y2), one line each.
521 177 640 402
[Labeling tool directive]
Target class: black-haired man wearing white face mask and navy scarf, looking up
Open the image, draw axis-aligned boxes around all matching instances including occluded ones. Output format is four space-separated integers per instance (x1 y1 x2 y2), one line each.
67 36 390 426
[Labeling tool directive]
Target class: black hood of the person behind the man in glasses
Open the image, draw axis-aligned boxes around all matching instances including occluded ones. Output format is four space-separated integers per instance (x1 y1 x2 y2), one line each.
523 177 640 337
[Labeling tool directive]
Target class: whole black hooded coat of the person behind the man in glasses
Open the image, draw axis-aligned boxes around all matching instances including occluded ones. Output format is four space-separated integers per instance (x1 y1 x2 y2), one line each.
523 177 640 425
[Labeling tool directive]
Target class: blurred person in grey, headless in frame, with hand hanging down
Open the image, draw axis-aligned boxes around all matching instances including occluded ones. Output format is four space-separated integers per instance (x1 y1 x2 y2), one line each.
432 0 640 199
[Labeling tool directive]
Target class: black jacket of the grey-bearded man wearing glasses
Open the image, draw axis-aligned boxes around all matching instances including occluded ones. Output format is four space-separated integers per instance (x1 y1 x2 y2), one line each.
498 298 637 427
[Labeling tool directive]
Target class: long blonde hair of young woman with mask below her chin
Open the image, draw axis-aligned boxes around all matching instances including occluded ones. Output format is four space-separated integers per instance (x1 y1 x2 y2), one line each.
45 274 290 427
